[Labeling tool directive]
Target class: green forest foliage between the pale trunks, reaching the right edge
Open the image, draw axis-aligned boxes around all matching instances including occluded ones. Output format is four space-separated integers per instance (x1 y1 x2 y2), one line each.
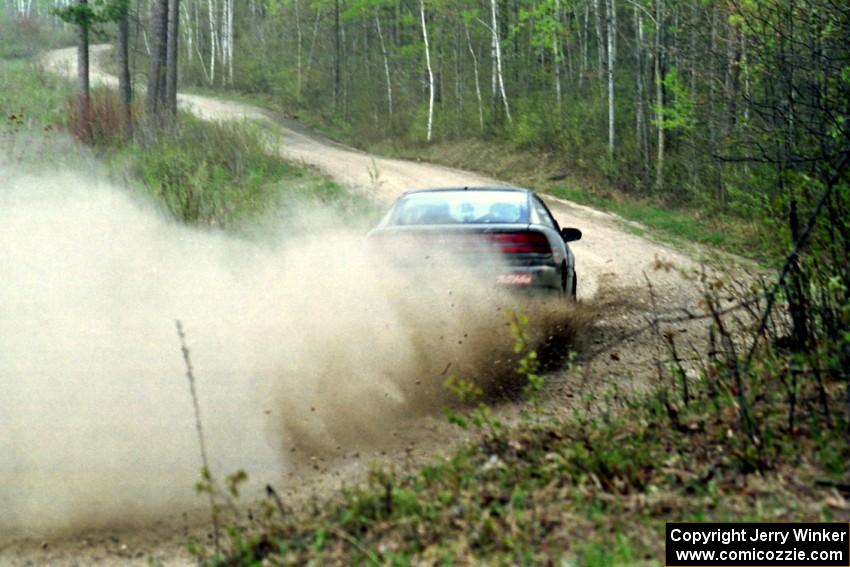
174 0 850 268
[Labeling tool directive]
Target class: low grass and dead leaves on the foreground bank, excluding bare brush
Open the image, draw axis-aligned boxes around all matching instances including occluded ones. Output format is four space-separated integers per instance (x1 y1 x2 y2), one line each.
210 370 850 567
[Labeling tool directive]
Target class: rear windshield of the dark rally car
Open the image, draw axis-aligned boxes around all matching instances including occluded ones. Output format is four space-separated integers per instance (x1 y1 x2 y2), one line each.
389 191 528 225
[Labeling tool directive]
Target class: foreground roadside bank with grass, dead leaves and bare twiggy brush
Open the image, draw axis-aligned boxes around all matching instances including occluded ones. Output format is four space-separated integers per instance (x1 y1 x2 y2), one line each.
187 262 850 567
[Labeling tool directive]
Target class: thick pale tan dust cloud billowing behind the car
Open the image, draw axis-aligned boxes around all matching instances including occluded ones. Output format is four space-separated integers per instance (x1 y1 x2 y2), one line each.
0 144 580 532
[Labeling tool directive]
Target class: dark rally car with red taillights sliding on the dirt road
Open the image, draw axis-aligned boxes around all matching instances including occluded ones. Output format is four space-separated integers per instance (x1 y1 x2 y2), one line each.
369 188 581 298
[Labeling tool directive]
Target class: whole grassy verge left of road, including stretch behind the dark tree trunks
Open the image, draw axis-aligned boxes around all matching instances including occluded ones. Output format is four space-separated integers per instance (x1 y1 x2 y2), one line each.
0 52 375 232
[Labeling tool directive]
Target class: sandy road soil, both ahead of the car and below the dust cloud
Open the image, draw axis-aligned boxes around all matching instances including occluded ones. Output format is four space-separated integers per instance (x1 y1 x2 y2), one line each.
0 46 716 565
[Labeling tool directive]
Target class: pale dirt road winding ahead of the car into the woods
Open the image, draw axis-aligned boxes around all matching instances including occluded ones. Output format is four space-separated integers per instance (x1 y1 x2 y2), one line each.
39 45 693 303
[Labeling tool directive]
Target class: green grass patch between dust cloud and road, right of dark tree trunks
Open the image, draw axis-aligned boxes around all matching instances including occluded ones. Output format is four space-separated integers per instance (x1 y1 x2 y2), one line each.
112 115 373 230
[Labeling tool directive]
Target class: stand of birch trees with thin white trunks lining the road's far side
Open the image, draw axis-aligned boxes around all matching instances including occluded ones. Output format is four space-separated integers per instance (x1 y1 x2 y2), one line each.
126 0 847 215
